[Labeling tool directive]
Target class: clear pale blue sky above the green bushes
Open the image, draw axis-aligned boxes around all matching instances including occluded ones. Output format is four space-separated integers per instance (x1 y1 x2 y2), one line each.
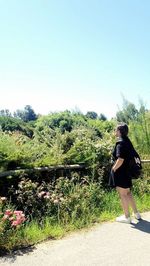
0 0 150 118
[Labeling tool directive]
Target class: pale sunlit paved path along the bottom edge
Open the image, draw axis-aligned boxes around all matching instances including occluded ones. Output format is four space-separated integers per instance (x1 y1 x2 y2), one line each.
0 212 150 266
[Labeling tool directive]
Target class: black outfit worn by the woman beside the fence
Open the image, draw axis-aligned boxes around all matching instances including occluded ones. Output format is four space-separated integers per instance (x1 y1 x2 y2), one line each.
109 137 133 188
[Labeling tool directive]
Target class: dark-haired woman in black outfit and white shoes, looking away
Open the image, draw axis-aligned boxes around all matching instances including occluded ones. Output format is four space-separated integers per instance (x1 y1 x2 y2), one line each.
111 123 141 223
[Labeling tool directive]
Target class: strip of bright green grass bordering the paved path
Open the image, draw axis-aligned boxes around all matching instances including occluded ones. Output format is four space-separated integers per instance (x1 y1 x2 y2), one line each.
0 190 150 255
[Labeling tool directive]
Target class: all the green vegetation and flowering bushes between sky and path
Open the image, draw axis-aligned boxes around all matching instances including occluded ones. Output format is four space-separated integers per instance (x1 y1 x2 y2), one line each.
0 101 150 254
